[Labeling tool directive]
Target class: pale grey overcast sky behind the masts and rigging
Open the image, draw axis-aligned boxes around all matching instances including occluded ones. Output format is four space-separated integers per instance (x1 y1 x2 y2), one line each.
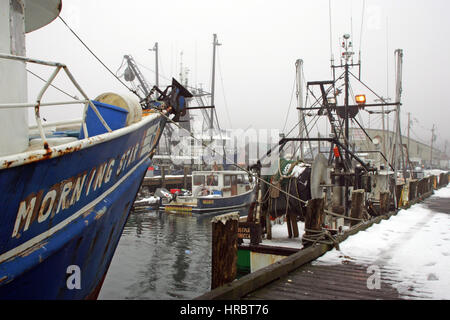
27 0 450 149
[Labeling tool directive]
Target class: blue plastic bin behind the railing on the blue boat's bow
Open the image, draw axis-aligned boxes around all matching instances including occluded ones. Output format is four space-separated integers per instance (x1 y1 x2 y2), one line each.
79 100 128 139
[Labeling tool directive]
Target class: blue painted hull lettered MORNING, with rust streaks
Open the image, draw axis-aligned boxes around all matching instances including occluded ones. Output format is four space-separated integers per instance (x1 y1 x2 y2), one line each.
0 115 165 299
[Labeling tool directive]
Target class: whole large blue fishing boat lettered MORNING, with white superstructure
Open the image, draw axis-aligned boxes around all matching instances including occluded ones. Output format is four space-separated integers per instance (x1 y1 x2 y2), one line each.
0 0 189 299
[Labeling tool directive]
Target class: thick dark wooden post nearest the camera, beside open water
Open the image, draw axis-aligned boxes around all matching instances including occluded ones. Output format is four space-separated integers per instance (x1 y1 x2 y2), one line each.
211 212 239 289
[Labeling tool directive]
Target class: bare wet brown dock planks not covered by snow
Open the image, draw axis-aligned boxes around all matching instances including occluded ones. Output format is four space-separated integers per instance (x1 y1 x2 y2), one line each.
242 194 450 300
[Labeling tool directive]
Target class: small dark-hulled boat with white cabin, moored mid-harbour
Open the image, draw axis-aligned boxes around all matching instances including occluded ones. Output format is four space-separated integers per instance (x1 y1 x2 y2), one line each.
161 170 256 215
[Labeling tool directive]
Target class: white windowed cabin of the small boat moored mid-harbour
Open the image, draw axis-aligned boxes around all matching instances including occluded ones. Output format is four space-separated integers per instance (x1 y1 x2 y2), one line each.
192 170 252 197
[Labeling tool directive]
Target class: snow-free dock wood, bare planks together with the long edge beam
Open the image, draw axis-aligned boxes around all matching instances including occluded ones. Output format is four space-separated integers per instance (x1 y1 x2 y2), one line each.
196 175 450 300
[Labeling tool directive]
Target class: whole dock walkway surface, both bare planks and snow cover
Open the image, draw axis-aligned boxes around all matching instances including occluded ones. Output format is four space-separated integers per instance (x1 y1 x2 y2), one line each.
245 186 450 299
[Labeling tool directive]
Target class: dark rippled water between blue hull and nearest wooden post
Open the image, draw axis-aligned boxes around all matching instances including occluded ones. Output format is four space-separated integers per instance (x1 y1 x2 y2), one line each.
98 211 211 300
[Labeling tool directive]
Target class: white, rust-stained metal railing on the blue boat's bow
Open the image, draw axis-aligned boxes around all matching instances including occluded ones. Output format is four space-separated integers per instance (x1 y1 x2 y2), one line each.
0 53 112 147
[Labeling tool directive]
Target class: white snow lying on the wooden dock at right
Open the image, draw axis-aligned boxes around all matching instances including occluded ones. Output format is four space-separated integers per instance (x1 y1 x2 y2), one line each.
313 186 450 299
